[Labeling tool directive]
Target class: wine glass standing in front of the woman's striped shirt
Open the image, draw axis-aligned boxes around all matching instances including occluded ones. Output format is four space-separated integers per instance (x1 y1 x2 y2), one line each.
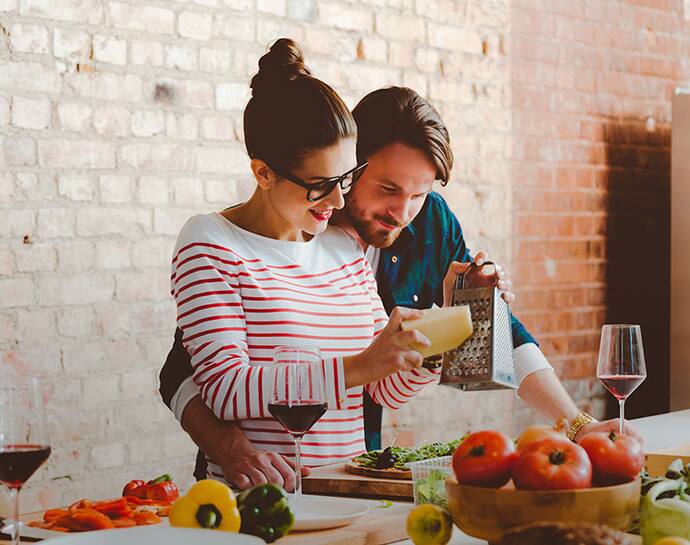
268 346 328 501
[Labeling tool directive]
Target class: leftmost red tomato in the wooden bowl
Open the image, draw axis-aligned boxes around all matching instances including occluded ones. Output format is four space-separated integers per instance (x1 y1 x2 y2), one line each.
453 431 515 488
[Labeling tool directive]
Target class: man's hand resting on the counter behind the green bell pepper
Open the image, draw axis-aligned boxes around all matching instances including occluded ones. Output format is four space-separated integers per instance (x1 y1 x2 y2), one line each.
217 442 309 492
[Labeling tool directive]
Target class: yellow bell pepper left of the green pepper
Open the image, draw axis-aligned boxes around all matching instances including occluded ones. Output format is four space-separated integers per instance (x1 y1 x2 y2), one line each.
170 479 241 532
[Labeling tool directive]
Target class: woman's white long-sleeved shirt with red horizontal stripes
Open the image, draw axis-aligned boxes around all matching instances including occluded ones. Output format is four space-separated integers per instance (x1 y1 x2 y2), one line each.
171 213 438 478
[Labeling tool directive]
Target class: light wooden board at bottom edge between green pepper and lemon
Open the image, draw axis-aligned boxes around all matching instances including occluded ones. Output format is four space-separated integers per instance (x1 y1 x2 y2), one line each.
276 503 414 545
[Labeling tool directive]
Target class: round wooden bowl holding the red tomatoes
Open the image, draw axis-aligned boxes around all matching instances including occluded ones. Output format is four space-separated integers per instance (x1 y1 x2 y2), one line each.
446 476 641 542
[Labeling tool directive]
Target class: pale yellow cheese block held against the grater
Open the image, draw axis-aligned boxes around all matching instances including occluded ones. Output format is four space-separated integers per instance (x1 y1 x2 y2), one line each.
400 305 472 358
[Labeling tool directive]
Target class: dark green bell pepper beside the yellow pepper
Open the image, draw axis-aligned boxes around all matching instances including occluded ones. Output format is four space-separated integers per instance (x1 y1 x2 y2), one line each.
237 484 295 543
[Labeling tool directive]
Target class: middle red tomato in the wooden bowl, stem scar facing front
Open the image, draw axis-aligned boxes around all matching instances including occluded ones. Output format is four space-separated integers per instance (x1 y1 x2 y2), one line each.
513 437 592 490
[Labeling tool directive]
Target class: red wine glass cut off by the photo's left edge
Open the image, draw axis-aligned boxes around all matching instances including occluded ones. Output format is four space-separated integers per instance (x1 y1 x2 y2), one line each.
0 376 50 545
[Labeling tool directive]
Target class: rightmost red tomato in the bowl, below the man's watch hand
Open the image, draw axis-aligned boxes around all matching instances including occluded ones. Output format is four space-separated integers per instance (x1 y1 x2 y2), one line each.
579 431 644 485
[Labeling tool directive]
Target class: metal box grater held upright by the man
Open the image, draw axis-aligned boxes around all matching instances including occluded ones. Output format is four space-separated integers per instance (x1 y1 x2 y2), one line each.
440 262 517 391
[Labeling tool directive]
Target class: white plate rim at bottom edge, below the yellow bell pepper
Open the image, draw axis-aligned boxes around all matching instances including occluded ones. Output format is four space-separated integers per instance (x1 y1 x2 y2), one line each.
43 526 266 545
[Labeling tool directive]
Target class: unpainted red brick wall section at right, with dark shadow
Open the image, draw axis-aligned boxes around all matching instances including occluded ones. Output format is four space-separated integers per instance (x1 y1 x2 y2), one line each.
511 0 690 424
